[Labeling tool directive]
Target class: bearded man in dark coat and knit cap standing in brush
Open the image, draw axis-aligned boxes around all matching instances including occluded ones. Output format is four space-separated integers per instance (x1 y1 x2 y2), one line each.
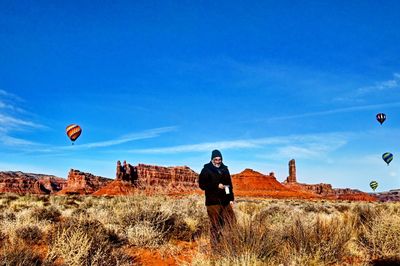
199 150 236 250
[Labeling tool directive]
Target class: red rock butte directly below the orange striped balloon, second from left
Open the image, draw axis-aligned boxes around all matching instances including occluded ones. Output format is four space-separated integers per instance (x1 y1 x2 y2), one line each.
59 169 112 194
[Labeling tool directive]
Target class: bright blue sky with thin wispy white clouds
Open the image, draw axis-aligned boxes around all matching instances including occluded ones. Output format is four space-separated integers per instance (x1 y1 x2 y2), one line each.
0 0 400 191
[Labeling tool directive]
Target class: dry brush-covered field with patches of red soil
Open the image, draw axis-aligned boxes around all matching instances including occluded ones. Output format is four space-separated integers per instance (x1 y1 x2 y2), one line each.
0 194 400 266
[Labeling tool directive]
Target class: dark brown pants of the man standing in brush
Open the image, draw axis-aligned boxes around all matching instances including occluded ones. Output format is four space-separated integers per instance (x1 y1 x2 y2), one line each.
207 204 236 251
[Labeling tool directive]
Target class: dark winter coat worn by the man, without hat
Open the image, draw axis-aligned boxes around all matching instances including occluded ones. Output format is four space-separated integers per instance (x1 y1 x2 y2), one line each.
199 162 234 206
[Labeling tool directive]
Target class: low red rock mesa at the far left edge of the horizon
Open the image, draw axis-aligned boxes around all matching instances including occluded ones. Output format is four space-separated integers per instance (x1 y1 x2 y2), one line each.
0 171 66 194
